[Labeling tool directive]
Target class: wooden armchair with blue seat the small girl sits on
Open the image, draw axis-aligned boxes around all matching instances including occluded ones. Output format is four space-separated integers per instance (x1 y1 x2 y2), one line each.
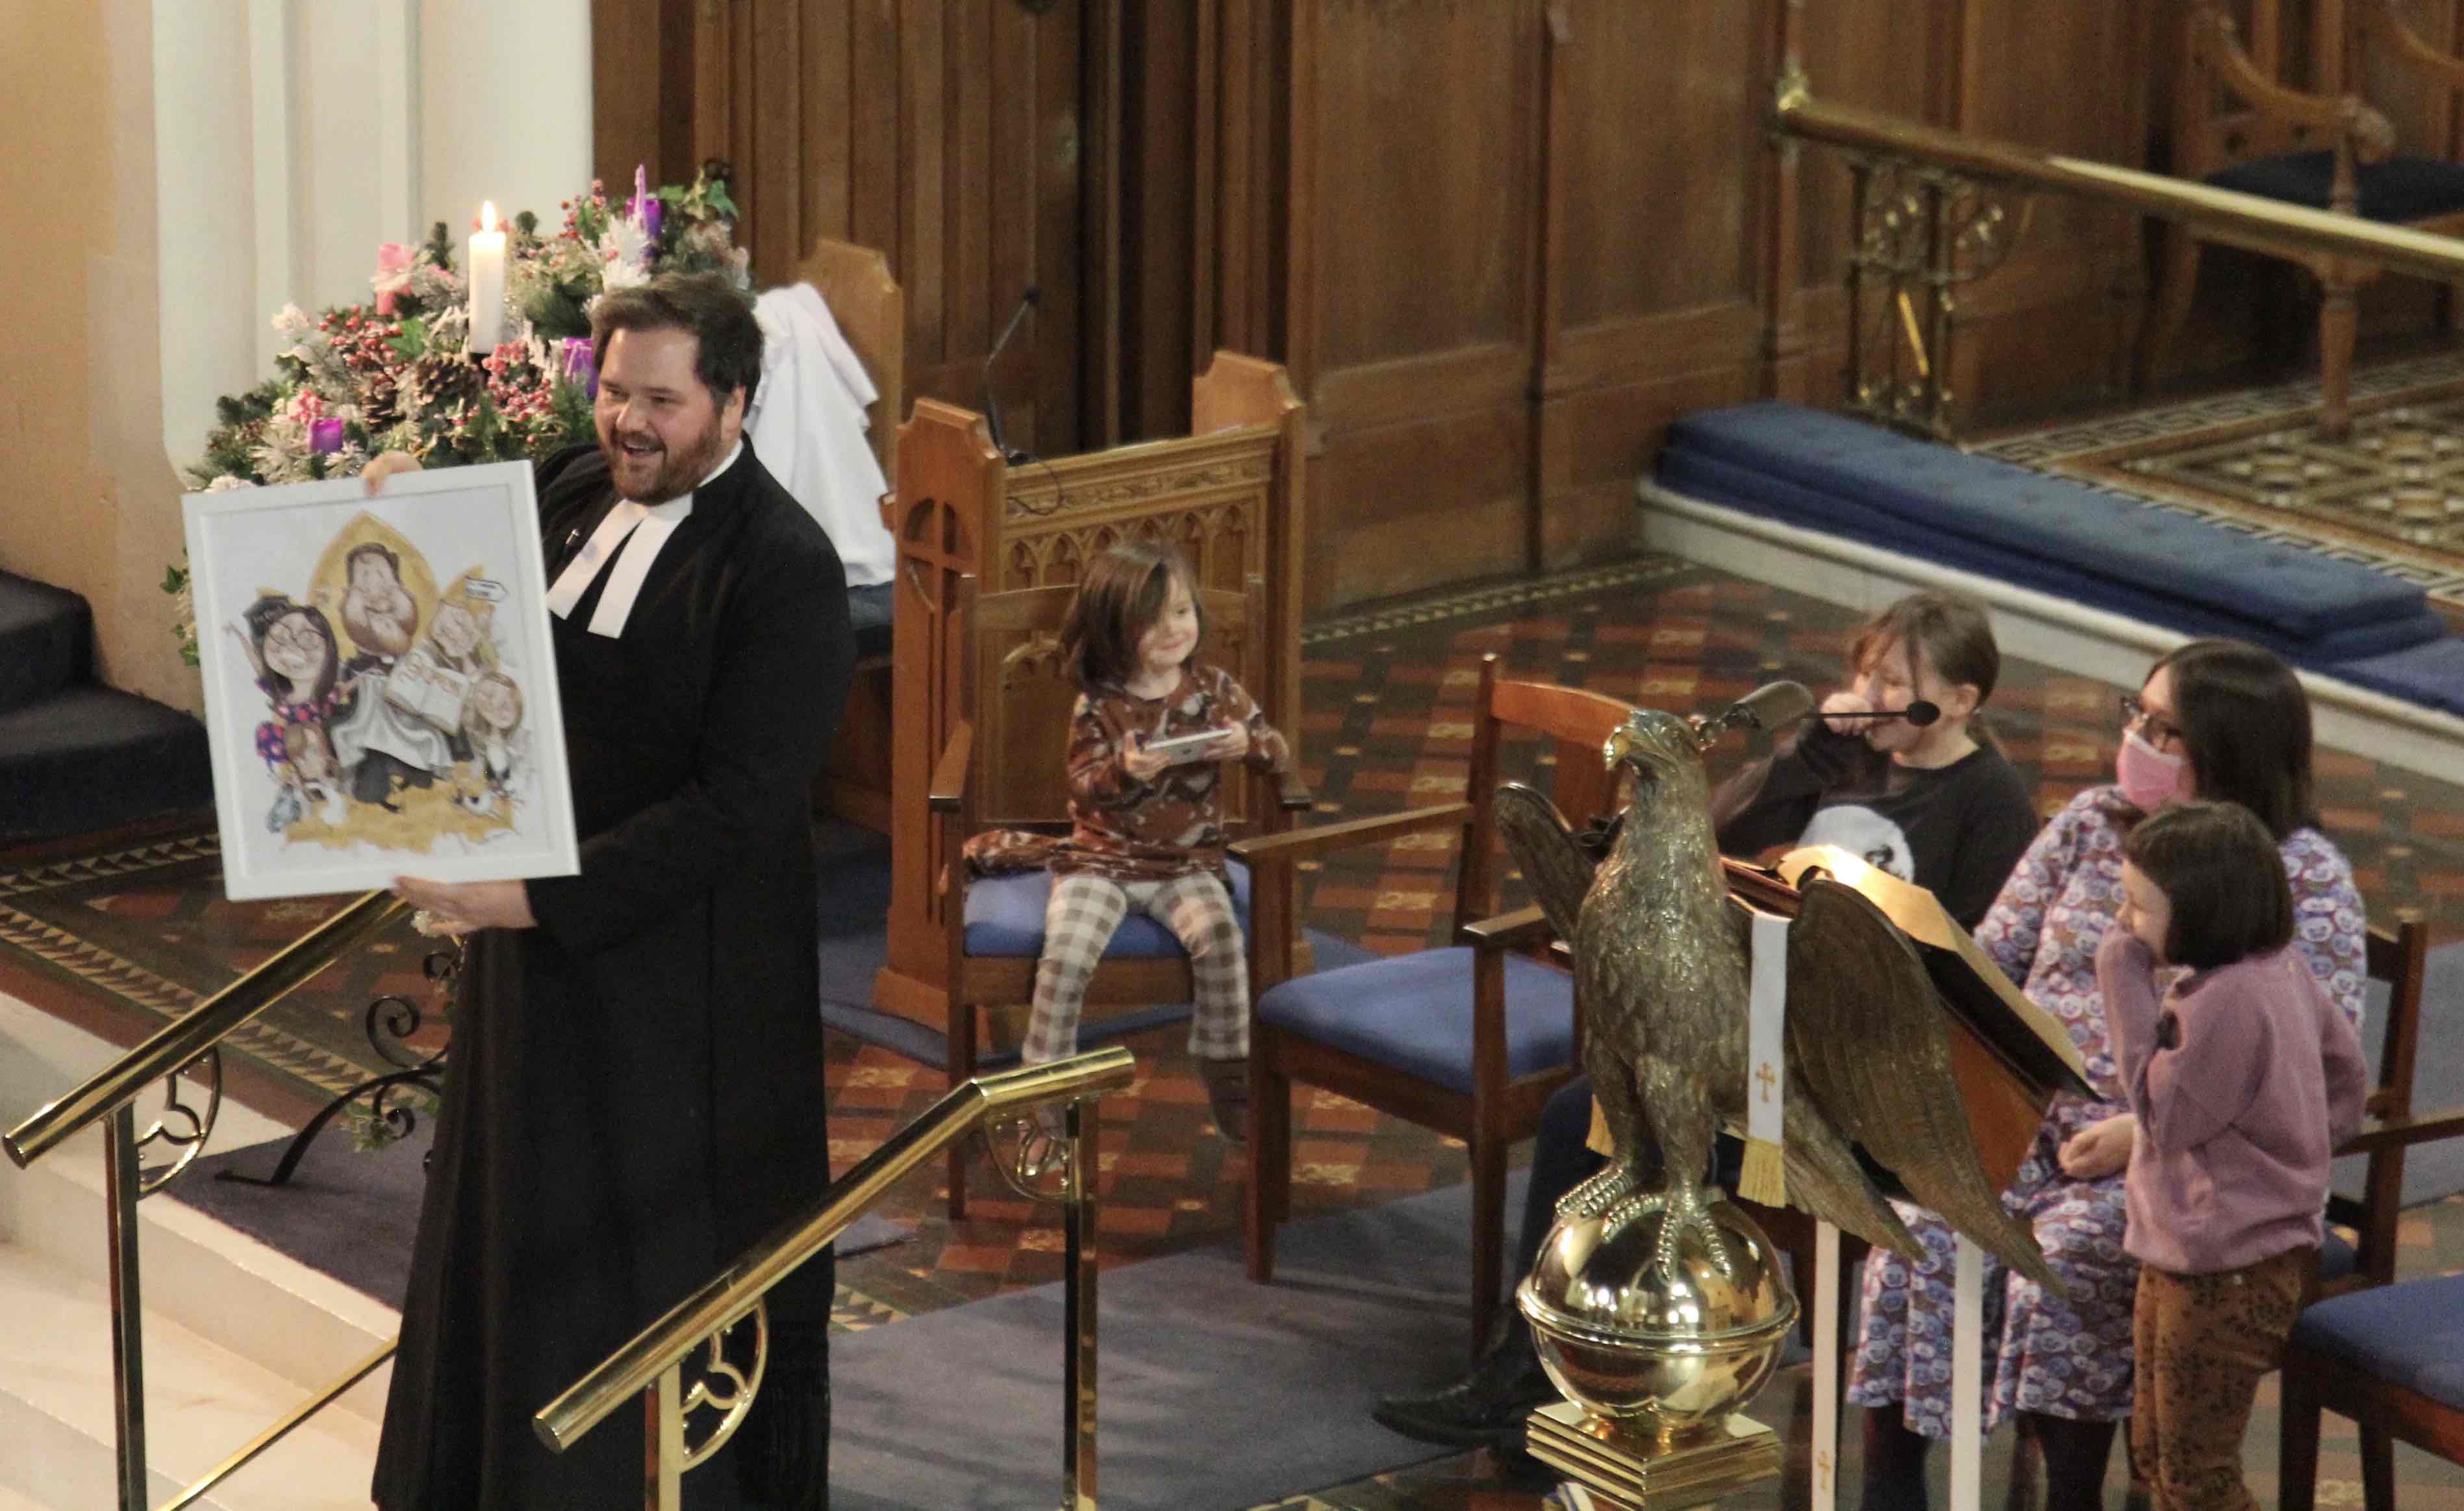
931 574 1309 1220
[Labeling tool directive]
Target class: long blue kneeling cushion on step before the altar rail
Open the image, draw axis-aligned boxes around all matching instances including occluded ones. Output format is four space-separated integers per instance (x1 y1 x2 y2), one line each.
1663 402 2445 640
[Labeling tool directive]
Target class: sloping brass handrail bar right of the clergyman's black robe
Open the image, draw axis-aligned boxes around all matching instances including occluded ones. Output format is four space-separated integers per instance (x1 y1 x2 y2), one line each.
530 1045 1136 1452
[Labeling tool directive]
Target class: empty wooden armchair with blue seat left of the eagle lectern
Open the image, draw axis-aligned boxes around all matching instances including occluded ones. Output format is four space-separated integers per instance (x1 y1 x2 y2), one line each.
1232 656 1633 1353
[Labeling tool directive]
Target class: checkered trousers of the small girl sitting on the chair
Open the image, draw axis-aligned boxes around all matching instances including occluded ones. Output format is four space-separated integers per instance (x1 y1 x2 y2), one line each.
1020 870 1250 1065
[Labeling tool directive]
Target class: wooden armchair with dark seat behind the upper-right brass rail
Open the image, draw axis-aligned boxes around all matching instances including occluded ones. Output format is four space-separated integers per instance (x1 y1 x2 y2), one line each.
2139 0 2464 439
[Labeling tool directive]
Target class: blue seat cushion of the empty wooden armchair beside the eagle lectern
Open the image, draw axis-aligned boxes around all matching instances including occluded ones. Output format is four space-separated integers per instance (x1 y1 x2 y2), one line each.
1257 947 1574 1097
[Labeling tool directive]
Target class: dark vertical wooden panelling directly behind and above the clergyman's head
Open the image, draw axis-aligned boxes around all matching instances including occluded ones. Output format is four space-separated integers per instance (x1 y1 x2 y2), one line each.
640 0 1094 453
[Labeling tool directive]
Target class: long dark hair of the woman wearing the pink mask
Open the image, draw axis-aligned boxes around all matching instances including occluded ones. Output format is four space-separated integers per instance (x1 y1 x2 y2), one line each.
2148 641 2319 843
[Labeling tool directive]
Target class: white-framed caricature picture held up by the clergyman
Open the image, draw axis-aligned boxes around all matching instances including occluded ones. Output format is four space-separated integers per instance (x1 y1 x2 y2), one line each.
182 461 579 900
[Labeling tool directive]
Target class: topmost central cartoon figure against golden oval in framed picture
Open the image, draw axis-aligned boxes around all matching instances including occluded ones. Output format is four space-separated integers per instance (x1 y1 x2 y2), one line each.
330 542 460 814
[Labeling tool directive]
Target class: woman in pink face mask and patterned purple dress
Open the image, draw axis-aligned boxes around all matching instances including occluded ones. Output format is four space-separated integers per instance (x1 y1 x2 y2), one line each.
1848 641 2365 1511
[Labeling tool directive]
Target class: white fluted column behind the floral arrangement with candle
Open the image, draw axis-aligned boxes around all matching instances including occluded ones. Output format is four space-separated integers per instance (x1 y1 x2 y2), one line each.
156 0 592 466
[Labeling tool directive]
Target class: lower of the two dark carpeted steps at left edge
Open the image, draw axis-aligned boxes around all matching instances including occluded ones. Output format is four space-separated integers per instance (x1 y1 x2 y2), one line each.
0 680 214 838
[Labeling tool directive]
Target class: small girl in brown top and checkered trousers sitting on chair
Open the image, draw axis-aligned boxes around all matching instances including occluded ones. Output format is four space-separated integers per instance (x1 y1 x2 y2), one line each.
968 542 1291 1173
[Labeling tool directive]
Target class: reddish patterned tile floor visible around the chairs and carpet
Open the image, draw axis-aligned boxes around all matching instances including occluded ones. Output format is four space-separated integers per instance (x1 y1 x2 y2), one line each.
0 542 2464 1511
